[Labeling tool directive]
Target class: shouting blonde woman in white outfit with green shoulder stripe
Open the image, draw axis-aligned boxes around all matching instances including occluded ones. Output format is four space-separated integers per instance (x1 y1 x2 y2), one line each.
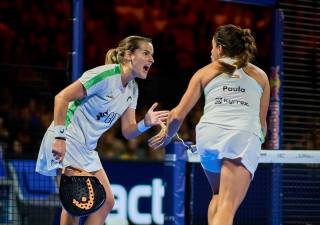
36 36 168 225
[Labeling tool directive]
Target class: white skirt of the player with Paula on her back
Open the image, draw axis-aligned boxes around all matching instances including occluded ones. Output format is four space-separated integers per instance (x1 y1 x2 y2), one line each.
196 123 261 178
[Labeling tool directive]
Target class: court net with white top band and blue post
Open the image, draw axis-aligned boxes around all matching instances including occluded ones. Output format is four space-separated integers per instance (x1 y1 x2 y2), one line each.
164 142 320 225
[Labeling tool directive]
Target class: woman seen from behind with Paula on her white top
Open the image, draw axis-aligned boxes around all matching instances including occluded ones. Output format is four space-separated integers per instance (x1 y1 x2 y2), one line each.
149 25 270 225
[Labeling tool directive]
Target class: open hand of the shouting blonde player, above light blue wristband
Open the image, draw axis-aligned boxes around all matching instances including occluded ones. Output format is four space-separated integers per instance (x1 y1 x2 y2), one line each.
144 102 169 127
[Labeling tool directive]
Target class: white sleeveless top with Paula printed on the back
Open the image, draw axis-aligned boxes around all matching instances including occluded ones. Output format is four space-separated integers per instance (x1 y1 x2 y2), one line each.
199 69 263 136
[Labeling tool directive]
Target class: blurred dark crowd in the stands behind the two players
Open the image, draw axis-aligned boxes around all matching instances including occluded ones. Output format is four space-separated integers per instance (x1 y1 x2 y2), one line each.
0 0 288 160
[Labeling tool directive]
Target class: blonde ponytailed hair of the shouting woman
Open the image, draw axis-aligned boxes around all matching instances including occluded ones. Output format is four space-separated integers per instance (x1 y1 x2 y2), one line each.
105 36 152 64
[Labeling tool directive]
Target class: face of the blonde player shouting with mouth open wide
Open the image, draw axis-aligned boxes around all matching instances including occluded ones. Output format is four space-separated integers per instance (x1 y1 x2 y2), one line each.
131 42 154 79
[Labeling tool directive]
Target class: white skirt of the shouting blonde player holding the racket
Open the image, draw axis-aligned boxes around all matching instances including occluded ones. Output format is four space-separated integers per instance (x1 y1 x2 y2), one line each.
36 130 103 176
